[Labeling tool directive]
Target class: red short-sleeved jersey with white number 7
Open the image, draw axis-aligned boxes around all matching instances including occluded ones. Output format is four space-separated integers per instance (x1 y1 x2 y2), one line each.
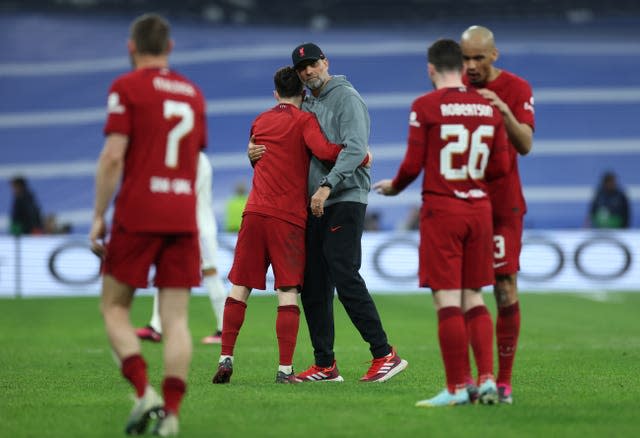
104 68 207 233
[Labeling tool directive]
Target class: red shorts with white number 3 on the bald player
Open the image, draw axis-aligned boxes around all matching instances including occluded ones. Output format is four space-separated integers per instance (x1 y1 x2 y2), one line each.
493 216 523 275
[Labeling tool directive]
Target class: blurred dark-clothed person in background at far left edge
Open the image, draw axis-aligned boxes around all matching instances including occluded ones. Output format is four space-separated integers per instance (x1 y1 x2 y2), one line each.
10 176 43 236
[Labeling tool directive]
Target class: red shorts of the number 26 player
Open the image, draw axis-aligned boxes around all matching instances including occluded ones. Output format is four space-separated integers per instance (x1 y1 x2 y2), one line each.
419 209 494 290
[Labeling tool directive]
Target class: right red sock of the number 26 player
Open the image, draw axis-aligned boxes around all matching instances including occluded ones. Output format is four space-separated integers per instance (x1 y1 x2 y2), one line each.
464 305 494 384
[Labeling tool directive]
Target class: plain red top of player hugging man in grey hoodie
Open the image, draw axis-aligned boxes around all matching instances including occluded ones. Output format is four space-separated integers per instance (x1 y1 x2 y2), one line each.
244 104 344 227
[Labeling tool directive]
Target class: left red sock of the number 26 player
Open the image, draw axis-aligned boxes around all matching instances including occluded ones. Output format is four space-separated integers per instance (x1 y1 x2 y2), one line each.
438 306 469 393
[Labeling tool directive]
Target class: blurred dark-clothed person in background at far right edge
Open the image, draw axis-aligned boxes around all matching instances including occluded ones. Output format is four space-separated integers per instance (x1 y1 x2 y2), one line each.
589 172 630 228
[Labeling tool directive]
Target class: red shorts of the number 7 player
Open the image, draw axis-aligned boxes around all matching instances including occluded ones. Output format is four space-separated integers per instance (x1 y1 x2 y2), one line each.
103 225 201 288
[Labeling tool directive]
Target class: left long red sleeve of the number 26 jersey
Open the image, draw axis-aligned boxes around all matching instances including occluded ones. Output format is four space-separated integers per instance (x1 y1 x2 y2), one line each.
392 101 427 191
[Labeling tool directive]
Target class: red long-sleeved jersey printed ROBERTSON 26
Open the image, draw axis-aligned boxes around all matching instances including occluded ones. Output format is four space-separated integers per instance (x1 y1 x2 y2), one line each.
393 87 508 214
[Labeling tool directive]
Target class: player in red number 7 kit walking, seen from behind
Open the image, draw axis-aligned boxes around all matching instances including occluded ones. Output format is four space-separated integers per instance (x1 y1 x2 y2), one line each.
89 14 206 436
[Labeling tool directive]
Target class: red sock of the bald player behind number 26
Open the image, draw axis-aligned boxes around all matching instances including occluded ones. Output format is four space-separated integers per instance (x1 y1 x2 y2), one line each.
496 302 520 385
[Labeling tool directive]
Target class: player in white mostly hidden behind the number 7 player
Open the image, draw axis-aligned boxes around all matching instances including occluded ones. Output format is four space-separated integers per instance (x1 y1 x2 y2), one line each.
136 152 227 344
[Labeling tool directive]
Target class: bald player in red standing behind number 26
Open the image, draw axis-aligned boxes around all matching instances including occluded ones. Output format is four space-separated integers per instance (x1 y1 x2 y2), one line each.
460 26 535 404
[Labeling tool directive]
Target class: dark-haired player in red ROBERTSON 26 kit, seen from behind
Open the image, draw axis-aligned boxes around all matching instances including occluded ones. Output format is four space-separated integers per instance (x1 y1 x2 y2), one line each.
374 39 507 407
